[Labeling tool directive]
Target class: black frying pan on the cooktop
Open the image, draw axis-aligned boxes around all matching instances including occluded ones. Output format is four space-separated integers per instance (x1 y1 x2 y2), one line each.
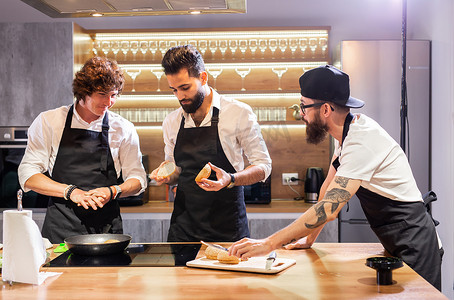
65 233 131 255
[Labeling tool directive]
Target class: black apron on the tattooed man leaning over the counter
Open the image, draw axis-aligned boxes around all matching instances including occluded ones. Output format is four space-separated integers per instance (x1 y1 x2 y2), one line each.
333 113 443 290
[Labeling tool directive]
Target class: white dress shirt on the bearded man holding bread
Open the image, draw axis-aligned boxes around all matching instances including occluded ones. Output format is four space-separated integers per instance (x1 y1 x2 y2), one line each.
162 89 271 181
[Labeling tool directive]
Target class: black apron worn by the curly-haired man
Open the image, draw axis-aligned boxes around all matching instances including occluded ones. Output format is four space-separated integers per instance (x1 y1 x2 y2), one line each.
42 105 123 244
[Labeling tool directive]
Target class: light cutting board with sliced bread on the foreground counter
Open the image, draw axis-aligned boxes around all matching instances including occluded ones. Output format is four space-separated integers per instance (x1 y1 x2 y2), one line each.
186 257 296 274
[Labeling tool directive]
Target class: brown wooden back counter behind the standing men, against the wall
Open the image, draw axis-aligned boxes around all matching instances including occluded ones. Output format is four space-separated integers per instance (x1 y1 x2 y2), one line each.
120 200 313 213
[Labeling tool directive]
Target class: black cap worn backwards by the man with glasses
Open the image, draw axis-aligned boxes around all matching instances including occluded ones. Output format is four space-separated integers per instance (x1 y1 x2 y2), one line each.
300 65 364 108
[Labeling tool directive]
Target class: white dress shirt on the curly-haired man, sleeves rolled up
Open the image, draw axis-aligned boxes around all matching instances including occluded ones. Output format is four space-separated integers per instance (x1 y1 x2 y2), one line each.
18 105 147 194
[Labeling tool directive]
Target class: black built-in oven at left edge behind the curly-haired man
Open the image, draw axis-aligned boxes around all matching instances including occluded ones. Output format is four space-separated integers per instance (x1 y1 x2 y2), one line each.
0 127 49 208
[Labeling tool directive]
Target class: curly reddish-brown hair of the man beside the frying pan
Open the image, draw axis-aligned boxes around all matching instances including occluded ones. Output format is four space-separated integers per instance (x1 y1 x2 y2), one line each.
73 56 125 101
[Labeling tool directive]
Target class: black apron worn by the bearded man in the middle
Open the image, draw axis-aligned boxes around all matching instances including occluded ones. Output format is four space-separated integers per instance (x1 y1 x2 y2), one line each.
167 107 249 242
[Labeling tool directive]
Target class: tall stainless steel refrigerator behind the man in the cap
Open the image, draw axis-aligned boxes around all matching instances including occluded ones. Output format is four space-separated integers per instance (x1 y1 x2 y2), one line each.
334 40 431 242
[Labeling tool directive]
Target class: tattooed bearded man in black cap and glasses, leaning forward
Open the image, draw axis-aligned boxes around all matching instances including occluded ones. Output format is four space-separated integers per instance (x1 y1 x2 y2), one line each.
229 65 443 290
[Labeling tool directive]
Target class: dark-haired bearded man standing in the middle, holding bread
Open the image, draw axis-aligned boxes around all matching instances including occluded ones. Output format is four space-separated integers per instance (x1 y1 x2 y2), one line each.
151 45 271 242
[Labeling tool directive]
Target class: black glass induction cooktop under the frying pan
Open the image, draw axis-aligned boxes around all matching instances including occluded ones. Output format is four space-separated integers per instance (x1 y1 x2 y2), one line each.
44 243 201 267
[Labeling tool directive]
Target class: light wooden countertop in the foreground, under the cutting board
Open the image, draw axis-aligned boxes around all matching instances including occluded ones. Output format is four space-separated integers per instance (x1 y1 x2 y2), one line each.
0 243 447 300
